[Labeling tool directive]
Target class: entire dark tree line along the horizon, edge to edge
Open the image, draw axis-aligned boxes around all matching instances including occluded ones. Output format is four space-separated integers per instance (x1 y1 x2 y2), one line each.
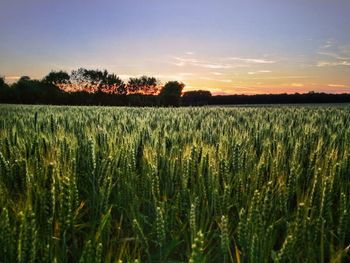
0 68 350 106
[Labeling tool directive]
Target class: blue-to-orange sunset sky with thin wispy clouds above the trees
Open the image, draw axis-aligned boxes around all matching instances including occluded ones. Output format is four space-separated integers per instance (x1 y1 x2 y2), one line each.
0 0 350 94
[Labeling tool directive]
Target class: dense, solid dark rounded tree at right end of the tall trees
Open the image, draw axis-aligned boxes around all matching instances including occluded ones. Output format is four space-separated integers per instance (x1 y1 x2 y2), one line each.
159 81 185 106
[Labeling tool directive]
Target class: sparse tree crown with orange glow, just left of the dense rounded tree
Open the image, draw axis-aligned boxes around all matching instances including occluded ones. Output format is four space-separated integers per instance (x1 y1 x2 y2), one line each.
127 76 159 95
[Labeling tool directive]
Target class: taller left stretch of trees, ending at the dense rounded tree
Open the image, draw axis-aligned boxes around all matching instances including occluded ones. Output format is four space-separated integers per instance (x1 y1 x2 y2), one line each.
0 68 185 106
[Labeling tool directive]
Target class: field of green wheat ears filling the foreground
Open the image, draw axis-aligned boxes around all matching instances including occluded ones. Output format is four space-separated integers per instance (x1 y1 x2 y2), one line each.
0 105 350 263
